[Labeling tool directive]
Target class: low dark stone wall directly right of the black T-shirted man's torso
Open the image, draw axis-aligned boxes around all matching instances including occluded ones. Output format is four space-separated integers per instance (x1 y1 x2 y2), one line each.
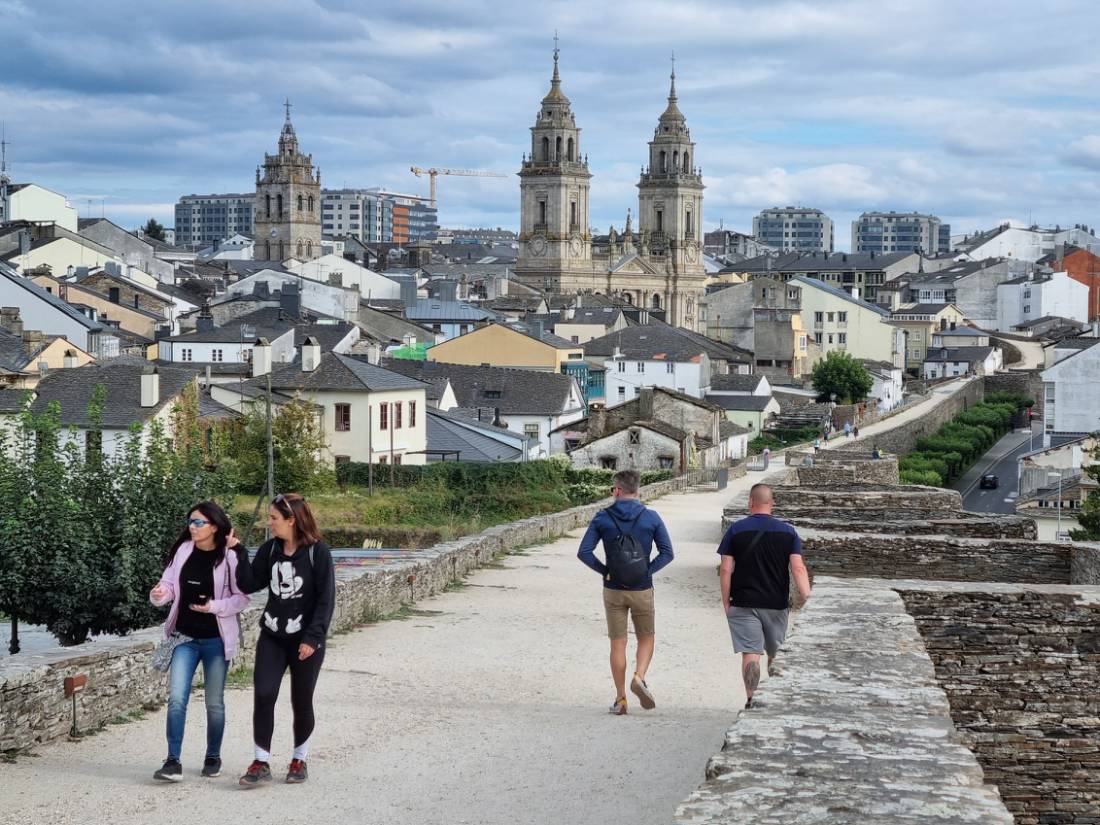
801 530 1070 584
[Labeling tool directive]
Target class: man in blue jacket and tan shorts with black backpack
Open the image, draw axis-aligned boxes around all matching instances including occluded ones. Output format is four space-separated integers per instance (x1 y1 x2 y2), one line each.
576 470 672 716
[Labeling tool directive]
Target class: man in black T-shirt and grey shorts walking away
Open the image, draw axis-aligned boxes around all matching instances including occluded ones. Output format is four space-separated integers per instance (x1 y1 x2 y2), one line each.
718 484 810 707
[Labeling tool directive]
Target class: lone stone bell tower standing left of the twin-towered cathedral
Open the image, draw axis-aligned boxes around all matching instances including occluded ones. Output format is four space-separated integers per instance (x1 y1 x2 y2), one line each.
252 100 321 261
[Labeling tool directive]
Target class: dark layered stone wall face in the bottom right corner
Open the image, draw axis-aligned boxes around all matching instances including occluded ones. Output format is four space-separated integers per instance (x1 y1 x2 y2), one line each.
897 583 1100 825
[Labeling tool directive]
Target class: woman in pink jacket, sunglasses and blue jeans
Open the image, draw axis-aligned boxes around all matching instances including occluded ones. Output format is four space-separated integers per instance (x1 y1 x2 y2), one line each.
149 502 250 782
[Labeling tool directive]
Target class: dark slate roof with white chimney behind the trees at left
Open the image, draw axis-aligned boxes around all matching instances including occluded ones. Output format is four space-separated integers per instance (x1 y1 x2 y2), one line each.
32 359 196 430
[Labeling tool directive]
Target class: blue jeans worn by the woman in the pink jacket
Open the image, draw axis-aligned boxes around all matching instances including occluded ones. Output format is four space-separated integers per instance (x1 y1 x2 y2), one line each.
168 637 229 759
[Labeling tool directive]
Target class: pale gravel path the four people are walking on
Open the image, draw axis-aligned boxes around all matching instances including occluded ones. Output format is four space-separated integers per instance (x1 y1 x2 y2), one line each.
0 488 760 825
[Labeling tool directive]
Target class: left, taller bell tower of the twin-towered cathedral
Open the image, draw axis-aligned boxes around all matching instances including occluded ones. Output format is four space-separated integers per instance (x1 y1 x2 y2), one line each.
516 37 592 292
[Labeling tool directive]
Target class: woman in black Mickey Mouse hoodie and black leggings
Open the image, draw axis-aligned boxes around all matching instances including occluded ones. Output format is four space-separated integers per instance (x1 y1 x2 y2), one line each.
238 493 337 788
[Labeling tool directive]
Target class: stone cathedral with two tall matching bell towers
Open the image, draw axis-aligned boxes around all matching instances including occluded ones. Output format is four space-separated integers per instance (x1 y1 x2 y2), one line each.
516 48 706 329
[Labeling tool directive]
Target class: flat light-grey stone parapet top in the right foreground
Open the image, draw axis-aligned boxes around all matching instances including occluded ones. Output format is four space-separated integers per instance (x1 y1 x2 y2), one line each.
674 579 1013 825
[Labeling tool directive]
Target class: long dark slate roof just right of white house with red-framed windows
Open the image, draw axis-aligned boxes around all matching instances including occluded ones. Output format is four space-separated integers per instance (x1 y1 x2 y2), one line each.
383 359 575 416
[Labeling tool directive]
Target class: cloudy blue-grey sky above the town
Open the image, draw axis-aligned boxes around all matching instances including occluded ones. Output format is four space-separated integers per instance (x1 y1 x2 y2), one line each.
0 0 1100 249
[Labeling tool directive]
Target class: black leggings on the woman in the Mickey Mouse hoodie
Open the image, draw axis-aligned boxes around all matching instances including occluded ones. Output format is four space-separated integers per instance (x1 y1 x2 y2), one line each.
252 633 325 751
